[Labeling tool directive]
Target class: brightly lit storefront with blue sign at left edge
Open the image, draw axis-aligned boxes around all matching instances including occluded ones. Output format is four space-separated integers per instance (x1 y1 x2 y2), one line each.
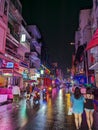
0 58 22 87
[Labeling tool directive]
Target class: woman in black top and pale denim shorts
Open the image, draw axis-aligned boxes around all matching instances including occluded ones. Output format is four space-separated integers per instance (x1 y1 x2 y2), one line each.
84 88 94 130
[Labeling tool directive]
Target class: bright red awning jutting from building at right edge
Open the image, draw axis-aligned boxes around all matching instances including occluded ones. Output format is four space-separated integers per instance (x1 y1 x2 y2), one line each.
86 29 98 51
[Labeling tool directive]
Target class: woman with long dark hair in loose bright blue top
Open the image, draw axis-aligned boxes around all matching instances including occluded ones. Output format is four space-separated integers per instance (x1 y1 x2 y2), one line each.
71 87 85 130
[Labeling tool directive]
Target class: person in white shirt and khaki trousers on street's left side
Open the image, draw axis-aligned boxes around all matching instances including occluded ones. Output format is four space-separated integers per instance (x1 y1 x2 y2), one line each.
12 84 20 107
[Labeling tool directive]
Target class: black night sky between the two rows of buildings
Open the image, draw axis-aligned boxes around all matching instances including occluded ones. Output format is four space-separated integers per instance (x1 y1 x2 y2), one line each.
21 0 92 70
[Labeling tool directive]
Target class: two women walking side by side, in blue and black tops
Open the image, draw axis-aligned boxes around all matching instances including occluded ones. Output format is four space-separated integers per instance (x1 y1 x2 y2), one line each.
71 87 98 130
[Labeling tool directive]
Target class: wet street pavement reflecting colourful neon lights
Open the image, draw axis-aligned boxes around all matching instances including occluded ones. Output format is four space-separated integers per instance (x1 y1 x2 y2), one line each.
0 89 98 130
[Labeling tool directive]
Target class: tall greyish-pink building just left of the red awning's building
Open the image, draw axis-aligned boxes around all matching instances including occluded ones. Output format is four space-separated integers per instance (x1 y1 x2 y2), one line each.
75 9 92 82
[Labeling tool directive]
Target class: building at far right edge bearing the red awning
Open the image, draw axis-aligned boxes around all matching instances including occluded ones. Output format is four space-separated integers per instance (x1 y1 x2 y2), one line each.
86 0 98 87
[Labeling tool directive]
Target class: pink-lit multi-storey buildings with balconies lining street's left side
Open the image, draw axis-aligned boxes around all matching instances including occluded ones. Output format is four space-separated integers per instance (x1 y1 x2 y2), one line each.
0 0 41 86
